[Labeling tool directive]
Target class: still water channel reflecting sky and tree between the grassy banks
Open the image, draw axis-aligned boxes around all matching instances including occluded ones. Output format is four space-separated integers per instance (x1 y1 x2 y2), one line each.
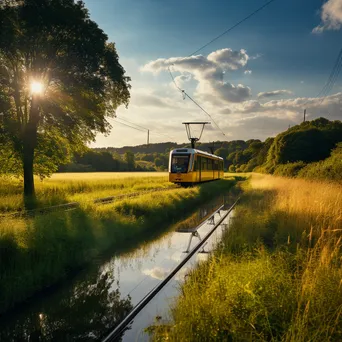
0 196 236 341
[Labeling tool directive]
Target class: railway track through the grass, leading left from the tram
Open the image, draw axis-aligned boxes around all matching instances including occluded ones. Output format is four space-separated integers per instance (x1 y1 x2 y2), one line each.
0 186 180 219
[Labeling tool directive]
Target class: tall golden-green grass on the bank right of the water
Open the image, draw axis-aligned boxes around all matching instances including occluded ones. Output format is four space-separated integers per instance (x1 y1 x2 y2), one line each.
151 174 342 342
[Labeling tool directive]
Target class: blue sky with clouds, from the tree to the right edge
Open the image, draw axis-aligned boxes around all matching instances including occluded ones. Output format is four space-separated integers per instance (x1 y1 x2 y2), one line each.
84 0 342 147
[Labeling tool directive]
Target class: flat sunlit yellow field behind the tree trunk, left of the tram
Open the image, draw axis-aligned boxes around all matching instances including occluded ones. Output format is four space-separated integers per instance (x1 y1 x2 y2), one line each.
0 172 173 213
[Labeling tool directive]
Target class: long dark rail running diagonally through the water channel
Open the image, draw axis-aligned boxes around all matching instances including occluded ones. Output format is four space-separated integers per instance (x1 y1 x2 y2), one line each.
102 198 239 342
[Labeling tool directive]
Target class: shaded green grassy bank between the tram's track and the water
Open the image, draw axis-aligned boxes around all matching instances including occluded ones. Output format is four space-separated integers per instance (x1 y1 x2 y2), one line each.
0 180 234 312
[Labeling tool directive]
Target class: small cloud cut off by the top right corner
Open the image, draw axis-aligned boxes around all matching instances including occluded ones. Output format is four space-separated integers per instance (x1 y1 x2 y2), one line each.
312 0 342 33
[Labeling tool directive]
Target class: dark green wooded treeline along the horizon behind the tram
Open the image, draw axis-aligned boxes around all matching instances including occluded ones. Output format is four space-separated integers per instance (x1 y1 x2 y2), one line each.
60 118 342 180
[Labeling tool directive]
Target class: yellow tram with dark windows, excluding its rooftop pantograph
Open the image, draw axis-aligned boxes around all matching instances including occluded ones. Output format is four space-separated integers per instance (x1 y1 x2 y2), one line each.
169 148 224 186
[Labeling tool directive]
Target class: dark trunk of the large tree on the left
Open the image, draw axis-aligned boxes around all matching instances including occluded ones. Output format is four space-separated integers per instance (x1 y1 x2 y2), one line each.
22 101 39 209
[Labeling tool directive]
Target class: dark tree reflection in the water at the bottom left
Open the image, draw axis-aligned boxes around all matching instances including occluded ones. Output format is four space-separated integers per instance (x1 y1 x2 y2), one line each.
0 272 133 341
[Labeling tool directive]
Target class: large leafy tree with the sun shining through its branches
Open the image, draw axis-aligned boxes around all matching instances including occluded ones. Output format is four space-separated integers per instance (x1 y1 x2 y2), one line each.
0 0 130 196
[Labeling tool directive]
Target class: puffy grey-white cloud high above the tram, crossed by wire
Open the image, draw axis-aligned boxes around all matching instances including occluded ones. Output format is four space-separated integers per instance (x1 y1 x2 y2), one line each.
142 48 251 105
